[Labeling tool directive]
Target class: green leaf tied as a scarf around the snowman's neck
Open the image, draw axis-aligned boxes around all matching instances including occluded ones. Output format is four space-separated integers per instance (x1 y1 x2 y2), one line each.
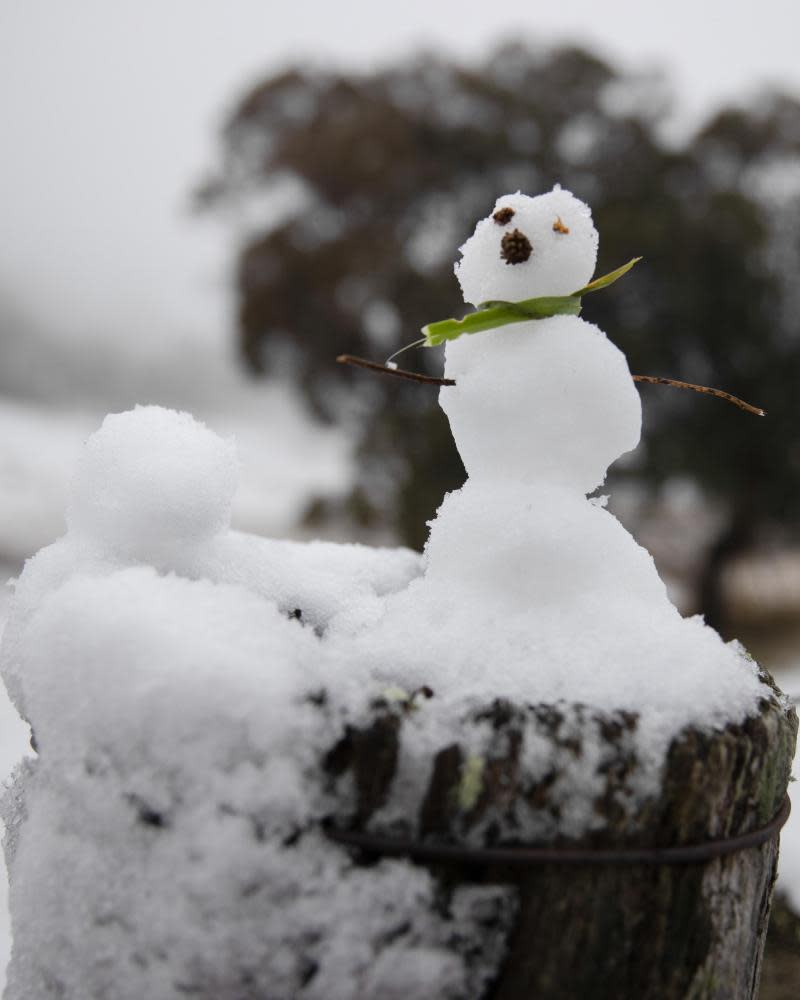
422 257 642 347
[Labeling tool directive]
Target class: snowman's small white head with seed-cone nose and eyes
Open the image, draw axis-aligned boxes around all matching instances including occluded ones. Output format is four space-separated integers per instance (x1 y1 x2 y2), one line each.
455 186 597 306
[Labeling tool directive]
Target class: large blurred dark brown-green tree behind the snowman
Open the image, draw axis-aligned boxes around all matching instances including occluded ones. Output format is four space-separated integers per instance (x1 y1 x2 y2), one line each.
199 44 800 625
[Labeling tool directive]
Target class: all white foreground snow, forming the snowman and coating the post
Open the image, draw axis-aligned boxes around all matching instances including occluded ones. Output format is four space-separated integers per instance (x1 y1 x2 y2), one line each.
0 190 780 1000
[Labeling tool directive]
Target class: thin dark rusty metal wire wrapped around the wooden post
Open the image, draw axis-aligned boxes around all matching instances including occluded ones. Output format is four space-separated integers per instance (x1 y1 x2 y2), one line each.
325 795 791 865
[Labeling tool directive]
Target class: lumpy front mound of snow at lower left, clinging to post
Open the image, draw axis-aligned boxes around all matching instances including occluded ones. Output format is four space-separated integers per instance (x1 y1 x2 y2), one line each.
0 566 511 1000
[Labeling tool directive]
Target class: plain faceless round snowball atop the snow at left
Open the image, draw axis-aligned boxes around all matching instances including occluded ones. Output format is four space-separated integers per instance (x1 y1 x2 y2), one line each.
67 406 238 561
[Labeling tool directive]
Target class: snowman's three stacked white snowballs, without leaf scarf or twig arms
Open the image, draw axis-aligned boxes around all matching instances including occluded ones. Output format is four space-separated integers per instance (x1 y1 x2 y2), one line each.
426 188 668 611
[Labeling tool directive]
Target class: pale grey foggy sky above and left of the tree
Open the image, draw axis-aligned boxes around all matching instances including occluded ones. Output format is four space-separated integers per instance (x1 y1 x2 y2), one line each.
0 0 800 352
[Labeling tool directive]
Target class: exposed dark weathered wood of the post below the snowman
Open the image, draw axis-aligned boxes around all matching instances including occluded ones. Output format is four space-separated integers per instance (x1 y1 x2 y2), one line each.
326 697 797 1000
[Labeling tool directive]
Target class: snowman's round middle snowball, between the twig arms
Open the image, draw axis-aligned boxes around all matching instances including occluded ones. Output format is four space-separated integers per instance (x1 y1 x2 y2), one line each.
439 316 641 493
